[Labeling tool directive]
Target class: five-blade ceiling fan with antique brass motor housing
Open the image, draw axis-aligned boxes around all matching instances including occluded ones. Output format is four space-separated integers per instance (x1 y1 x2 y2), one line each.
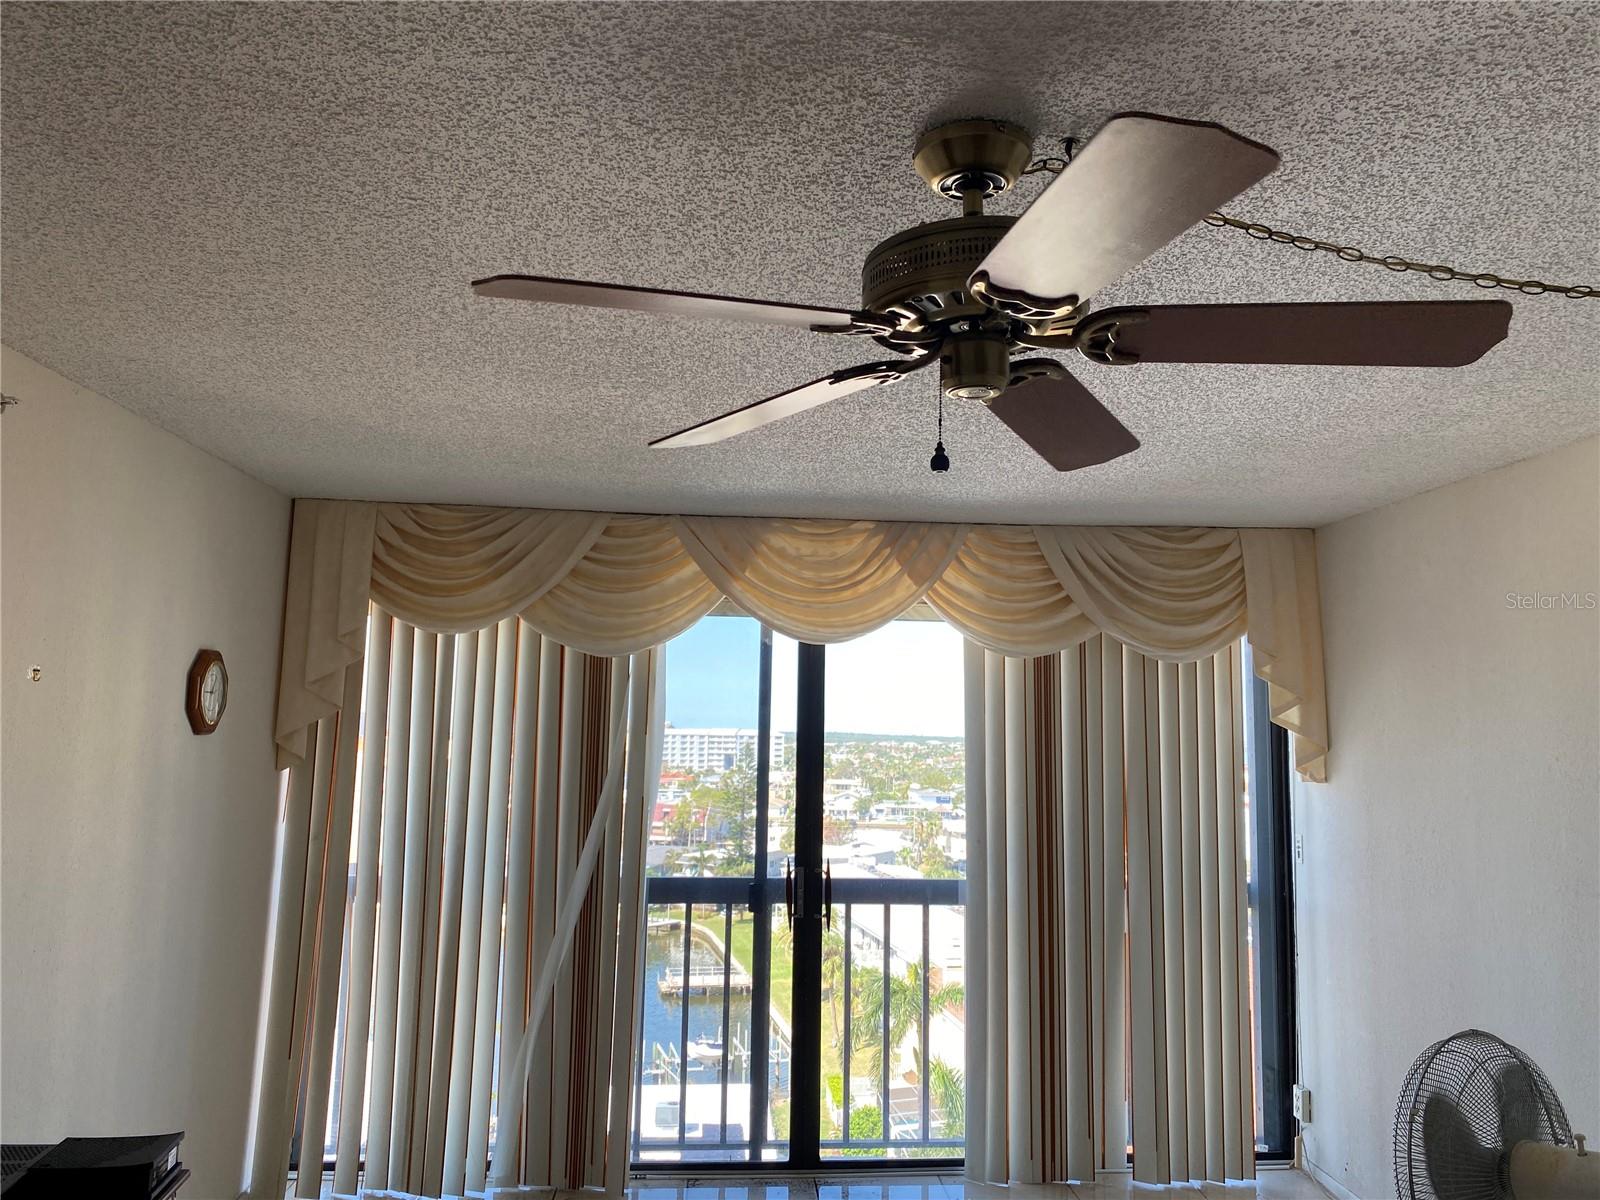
472 114 1510 470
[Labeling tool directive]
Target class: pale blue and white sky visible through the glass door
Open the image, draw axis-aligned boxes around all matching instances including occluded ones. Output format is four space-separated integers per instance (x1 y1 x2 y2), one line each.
667 616 962 738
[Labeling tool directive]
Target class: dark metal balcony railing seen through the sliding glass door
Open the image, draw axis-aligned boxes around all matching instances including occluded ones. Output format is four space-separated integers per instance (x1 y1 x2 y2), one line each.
632 877 965 1162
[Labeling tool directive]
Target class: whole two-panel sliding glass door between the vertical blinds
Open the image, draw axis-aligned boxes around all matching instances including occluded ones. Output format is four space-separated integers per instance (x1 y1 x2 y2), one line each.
634 616 966 1168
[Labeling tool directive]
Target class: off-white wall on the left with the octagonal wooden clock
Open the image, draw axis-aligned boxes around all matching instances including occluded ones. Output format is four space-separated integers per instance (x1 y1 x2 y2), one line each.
0 349 290 1198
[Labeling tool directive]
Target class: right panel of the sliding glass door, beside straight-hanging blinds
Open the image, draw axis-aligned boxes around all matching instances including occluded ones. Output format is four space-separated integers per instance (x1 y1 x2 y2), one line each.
819 621 966 1160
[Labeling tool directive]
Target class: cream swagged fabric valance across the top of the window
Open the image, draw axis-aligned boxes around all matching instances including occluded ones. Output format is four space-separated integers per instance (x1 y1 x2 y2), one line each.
275 499 1328 779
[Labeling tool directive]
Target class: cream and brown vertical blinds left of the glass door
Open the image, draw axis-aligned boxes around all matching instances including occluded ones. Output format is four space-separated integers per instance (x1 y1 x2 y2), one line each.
250 611 661 1200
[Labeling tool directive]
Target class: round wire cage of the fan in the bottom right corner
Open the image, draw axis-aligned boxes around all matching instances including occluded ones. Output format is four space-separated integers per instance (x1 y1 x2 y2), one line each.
1394 1029 1573 1200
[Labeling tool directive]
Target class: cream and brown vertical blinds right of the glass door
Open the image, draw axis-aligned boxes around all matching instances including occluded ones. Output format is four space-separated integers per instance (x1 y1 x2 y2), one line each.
966 640 1254 1184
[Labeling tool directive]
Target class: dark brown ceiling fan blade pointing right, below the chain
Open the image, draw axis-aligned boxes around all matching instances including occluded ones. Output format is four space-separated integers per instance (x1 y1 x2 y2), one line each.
1090 301 1510 366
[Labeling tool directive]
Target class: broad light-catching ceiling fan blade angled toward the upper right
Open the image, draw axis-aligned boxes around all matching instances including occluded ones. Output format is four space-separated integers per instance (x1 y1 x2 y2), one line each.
973 112 1278 307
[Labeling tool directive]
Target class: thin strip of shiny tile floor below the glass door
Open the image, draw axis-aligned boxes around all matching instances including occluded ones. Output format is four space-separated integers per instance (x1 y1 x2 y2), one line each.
629 1170 1328 1200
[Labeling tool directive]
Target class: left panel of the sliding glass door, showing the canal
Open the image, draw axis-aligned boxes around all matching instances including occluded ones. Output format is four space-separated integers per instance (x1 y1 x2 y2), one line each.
632 616 795 1163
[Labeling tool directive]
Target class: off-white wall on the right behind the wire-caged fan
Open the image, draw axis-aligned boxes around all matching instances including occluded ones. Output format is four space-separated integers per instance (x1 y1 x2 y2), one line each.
1294 438 1600 1197
